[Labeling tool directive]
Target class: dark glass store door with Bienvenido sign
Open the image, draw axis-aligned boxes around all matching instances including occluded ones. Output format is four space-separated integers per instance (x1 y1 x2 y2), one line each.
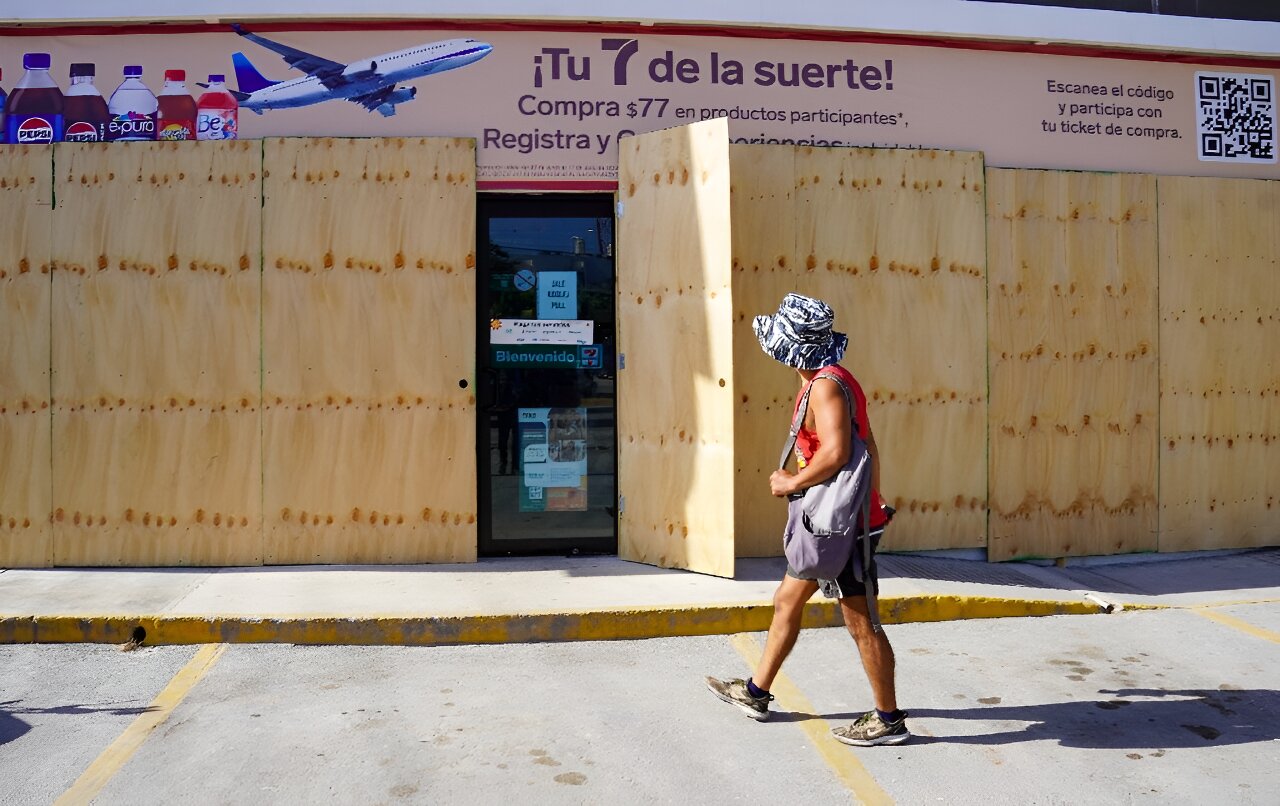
476 196 618 557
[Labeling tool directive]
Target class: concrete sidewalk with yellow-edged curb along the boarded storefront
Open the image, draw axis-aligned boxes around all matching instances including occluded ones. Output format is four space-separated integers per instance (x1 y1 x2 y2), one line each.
0 549 1280 645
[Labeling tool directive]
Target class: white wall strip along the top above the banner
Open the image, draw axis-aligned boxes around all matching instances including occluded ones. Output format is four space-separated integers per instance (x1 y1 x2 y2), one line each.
0 0 1280 58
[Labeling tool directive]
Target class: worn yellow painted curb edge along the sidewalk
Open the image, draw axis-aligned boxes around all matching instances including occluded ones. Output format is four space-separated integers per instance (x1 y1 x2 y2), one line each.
0 596 1141 646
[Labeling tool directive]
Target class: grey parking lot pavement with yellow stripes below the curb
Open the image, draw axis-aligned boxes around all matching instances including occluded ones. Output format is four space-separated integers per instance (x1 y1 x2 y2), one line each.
0 603 1280 805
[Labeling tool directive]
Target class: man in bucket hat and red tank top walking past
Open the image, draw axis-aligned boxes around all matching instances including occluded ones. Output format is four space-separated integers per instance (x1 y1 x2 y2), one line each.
707 294 911 746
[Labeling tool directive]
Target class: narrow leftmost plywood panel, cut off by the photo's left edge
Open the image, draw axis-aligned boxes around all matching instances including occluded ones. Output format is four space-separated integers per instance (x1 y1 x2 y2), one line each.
0 146 54 568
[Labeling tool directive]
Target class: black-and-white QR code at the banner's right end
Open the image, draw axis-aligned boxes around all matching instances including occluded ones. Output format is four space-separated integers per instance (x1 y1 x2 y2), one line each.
1196 73 1276 162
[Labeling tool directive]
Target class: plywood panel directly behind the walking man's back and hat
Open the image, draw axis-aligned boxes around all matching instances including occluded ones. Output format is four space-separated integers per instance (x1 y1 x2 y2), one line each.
791 147 987 549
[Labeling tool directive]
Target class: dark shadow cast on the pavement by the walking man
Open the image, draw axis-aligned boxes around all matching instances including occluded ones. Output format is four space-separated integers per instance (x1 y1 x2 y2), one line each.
793 688 1280 750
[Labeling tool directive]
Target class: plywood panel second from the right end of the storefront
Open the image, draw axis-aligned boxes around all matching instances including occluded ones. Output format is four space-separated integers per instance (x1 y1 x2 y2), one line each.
987 170 1158 559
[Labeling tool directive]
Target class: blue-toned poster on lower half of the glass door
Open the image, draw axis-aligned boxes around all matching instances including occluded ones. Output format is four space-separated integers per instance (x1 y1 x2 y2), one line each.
518 407 586 512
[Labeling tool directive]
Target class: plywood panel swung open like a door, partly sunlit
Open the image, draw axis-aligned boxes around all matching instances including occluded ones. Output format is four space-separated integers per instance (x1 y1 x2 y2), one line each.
617 119 735 577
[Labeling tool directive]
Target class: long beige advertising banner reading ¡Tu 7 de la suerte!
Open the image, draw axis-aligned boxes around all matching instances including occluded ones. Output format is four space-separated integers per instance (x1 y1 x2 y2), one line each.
0 24 1280 180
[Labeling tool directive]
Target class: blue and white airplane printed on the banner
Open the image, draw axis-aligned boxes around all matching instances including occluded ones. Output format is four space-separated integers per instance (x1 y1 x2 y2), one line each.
226 26 493 118
